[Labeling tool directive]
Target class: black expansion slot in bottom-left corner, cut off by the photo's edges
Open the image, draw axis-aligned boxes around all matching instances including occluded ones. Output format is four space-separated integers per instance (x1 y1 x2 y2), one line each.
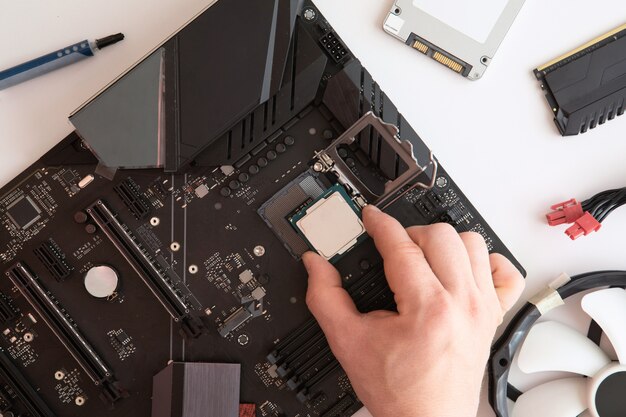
0 349 56 417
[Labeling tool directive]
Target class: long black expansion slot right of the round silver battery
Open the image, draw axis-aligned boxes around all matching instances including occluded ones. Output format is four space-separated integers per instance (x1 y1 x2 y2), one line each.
86 201 204 338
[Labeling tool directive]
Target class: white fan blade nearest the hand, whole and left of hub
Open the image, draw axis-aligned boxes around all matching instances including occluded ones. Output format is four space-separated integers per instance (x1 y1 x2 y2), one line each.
518 321 611 376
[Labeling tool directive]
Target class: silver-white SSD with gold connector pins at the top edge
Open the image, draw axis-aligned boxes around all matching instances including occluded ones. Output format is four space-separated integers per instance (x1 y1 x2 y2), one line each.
383 0 525 80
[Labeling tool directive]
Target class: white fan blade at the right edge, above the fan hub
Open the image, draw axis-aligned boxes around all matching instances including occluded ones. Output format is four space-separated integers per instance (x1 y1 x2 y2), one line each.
581 288 626 365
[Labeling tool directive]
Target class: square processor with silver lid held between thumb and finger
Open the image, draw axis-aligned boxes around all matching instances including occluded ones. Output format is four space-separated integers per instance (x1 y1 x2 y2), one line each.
289 185 366 262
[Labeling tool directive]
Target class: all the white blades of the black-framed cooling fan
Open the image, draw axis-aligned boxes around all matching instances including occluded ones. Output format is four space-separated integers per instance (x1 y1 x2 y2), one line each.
512 288 626 417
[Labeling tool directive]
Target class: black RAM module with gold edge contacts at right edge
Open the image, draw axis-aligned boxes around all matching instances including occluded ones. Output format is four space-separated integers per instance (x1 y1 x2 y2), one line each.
534 25 626 136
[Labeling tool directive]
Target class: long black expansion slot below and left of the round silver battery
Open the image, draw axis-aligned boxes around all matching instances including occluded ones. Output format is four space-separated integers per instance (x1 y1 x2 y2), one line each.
6 263 126 404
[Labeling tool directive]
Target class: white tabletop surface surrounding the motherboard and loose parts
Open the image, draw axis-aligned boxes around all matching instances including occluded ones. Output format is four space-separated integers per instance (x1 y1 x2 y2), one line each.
0 0 626 417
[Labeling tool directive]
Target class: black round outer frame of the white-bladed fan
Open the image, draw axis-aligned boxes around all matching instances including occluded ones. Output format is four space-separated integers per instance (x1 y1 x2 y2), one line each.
488 271 626 417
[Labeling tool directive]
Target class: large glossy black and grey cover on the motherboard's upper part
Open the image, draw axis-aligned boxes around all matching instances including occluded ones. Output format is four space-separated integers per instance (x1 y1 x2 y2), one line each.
70 0 299 171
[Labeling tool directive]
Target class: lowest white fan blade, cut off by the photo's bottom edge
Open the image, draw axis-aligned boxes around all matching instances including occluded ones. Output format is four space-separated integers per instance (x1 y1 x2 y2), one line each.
512 377 588 417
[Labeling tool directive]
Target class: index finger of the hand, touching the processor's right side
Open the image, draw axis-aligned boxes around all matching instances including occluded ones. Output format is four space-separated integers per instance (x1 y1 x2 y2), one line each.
363 206 443 306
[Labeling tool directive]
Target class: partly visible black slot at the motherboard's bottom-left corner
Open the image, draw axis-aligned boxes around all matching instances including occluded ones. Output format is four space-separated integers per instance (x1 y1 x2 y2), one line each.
0 349 56 417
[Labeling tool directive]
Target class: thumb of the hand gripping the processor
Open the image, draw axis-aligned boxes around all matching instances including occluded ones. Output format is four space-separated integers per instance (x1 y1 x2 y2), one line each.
302 252 360 336
